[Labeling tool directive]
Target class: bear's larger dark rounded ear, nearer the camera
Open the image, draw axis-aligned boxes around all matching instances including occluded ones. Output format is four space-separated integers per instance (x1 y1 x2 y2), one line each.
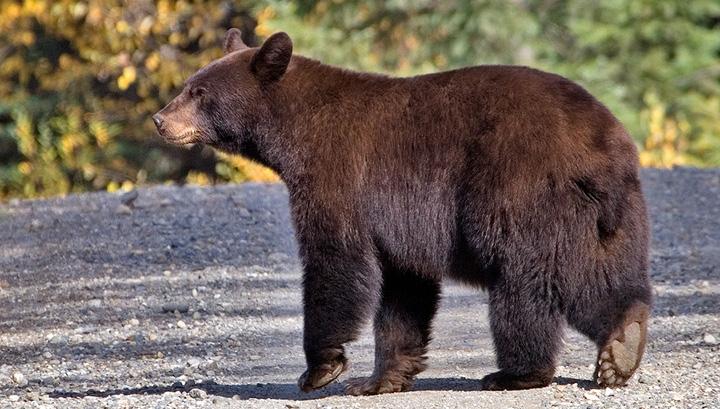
250 33 292 83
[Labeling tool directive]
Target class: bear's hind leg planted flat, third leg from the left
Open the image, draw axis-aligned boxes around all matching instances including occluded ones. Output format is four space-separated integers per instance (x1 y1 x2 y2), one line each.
481 274 562 390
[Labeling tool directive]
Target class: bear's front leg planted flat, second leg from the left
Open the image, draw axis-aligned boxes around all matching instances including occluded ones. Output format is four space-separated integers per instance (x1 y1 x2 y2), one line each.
347 270 440 395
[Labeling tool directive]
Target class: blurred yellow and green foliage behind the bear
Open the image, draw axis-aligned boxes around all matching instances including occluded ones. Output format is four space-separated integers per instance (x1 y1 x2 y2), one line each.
0 0 720 200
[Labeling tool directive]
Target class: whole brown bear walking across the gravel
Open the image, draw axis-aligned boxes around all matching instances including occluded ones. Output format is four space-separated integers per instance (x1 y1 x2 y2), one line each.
152 29 652 395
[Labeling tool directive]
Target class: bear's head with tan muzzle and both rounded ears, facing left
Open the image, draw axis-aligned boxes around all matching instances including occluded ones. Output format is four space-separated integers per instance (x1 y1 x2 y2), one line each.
152 28 292 153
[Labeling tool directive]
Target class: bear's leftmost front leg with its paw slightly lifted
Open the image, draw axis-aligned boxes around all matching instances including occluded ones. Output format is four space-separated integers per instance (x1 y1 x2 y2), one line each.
298 239 382 392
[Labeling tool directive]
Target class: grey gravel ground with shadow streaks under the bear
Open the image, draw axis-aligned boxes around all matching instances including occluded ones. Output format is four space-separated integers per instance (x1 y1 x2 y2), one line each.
0 168 720 409
